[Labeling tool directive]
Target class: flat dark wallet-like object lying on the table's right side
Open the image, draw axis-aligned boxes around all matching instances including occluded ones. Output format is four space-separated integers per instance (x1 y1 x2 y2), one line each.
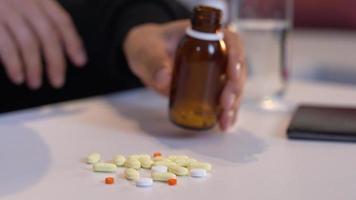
287 105 356 142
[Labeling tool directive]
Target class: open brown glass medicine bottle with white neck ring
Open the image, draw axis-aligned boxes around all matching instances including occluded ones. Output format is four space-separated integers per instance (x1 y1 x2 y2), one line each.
169 6 227 130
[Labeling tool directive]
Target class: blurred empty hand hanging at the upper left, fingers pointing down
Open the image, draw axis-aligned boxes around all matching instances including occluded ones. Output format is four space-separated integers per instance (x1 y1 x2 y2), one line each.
0 0 87 89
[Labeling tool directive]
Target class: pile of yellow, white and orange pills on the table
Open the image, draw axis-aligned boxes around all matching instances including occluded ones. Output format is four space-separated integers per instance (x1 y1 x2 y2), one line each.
87 152 212 187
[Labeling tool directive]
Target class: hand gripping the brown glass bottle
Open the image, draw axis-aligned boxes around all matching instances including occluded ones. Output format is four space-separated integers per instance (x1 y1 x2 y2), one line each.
124 20 246 131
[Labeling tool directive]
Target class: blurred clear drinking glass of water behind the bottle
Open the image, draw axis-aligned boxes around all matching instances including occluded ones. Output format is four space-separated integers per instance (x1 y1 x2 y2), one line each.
230 0 293 111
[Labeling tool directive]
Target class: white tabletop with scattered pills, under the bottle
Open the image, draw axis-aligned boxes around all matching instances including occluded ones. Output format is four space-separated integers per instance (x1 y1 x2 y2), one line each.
0 79 356 200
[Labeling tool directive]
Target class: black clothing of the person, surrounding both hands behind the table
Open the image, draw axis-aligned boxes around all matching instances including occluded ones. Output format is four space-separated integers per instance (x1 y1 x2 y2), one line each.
0 0 189 113
